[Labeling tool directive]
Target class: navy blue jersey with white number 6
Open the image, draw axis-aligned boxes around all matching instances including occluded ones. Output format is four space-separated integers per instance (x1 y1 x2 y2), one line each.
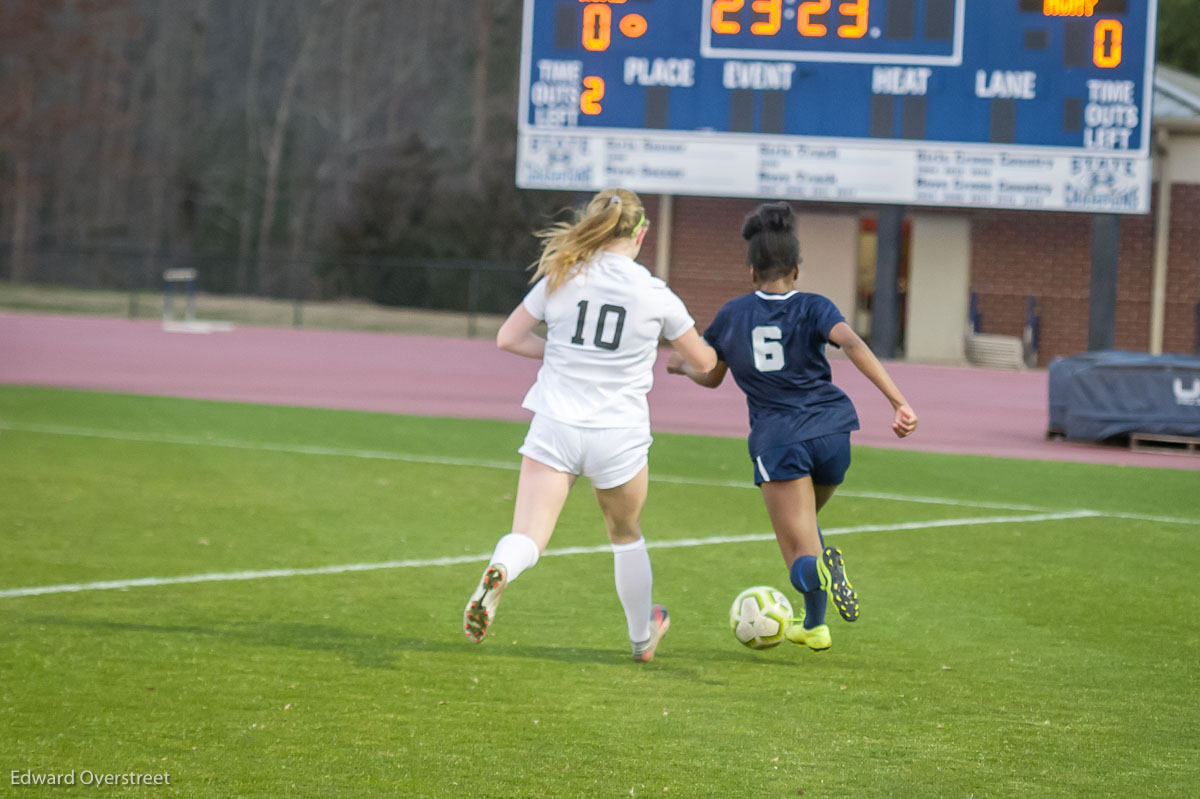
704 292 858 457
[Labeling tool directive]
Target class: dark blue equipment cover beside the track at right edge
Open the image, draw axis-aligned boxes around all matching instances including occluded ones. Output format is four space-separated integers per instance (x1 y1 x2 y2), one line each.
1048 350 1200 441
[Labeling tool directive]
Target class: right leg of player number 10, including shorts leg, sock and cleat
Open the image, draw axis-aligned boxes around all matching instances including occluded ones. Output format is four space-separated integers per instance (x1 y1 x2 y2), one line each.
587 431 671 662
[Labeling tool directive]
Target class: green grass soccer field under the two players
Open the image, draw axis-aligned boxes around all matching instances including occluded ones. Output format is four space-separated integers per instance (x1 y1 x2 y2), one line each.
0 388 1200 798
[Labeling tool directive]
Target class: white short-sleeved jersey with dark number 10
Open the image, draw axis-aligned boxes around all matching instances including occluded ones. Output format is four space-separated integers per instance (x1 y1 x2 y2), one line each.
522 251 696 427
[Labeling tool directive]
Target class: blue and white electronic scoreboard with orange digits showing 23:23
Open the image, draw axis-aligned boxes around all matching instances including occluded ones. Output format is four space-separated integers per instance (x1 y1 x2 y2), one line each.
517 0 1158 214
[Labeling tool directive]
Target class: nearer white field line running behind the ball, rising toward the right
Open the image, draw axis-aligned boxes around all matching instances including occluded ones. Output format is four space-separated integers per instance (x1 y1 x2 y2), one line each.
0 511 1096 599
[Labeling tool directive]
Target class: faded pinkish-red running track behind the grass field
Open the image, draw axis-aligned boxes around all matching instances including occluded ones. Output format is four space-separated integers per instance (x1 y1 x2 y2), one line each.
0 313 1200 469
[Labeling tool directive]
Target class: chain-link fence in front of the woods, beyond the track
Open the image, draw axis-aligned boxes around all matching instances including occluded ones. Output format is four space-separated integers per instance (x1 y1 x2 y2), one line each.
0 246 529 336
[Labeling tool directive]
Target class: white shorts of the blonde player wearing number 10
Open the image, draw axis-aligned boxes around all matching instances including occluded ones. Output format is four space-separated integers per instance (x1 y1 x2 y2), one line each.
517 414 654 489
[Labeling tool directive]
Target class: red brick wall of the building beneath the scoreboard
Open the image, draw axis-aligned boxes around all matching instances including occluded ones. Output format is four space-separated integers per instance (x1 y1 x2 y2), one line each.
667 185 1200 366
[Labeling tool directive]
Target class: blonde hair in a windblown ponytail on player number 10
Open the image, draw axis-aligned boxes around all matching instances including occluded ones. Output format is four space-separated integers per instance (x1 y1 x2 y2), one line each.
529 188 646 293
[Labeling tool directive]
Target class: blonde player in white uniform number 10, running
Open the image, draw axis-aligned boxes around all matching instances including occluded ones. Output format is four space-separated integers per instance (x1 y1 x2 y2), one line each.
463 188 716 662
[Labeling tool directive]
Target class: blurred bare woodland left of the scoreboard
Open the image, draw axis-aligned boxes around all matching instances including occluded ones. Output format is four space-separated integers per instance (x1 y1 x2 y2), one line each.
0 0 549 292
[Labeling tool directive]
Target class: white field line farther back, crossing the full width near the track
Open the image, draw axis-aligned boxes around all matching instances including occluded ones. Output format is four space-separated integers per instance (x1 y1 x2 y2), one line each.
0 420 1200 524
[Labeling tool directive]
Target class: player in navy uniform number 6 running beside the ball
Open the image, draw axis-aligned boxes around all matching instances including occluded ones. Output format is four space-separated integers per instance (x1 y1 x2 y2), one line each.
667 203 917 651
